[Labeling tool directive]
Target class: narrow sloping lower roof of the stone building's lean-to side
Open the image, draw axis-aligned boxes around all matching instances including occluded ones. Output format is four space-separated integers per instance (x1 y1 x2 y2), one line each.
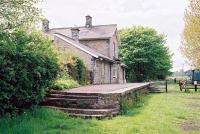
54 33 114 62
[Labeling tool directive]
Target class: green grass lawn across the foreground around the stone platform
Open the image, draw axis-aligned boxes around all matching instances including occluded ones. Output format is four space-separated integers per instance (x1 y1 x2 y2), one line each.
0 85 200 134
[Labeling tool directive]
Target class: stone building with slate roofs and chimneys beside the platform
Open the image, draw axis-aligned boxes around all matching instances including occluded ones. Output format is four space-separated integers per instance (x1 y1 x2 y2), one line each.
43 15 126 84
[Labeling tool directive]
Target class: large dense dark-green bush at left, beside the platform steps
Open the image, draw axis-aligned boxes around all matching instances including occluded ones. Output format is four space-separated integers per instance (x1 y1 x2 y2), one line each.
0 31 59 115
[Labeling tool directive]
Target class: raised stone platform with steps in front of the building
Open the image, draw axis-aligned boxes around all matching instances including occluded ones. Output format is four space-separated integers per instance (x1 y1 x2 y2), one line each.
42 83 151 119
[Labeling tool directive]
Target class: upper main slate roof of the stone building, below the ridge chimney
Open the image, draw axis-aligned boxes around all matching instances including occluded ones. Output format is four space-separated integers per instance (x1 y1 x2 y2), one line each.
48 24 117 40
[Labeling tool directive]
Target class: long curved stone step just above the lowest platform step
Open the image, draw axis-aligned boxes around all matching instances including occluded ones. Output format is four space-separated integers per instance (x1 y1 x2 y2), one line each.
45 107 119 115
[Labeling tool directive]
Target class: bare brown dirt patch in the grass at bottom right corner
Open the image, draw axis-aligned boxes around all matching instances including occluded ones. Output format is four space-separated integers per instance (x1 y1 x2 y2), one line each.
180 120 200 131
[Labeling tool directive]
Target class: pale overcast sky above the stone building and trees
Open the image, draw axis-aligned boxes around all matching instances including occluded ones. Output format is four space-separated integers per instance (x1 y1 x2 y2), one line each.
40 0 189 71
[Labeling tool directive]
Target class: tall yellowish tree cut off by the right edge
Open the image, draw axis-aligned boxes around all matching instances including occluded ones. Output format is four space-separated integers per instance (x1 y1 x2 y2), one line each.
181 0 200 69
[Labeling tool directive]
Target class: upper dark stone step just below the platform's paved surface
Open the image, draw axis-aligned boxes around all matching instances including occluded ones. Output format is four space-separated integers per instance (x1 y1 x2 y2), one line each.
47 94 99 99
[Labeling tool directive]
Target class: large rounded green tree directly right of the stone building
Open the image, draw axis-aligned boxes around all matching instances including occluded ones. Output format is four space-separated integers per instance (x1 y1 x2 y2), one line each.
120 26 172 82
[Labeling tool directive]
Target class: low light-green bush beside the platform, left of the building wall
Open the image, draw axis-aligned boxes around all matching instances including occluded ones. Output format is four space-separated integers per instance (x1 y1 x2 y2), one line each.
50 79 80 90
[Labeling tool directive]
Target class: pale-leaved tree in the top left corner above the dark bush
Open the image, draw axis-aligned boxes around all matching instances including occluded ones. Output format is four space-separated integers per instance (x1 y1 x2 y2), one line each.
0 0 42 30
